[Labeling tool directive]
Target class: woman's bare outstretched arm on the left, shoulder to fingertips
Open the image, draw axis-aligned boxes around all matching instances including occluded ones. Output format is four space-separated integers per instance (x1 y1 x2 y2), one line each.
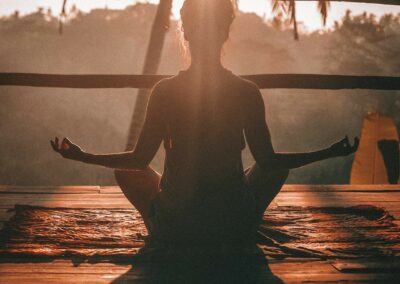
50 84 166 170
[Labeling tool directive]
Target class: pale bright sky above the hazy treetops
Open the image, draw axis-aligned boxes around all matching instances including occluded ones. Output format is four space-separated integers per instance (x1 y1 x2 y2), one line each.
0 0 400 30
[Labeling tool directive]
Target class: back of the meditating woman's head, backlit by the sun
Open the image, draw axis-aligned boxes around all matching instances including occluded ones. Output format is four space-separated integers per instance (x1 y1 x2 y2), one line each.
181 0 235 53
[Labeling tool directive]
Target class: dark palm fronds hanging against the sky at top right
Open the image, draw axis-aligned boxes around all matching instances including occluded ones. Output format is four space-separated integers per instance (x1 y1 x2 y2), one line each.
272 0 330 40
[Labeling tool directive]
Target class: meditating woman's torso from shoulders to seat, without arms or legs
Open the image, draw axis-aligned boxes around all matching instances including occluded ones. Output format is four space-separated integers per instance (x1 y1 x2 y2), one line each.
153 69 255 244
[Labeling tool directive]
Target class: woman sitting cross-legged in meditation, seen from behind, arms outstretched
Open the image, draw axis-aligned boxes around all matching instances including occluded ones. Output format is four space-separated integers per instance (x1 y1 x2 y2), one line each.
51 0 358 244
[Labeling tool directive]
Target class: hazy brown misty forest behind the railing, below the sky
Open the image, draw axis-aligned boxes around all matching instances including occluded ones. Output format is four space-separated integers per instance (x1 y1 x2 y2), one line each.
0 3 400 185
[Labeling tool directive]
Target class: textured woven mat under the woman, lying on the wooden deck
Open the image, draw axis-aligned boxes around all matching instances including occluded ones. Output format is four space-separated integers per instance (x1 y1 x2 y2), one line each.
0 205 400 259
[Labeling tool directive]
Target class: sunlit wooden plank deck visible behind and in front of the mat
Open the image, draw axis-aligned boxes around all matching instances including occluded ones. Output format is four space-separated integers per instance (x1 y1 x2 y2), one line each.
0 185 400 283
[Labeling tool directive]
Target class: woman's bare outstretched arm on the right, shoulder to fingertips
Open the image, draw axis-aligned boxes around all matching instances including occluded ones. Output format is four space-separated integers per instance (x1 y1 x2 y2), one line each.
244 86 358 171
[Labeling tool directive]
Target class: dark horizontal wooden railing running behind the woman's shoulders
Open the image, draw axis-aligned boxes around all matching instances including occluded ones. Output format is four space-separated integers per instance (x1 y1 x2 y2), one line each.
0 73 400 90
